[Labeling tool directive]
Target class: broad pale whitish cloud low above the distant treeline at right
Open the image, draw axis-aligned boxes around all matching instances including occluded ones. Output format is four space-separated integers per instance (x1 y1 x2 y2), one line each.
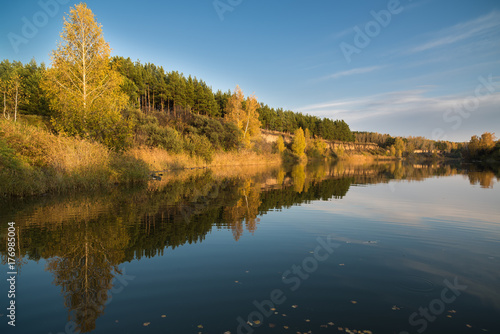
297 86 500 141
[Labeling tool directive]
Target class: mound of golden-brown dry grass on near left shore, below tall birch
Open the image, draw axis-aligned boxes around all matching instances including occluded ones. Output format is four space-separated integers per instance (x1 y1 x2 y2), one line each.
0 120 148 196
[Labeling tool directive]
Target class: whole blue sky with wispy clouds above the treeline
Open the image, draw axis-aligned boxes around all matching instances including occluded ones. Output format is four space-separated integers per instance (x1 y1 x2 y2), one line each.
0 0 500 141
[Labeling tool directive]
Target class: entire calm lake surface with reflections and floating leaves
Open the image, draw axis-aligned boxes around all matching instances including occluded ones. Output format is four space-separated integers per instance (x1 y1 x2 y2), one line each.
0 164 500 334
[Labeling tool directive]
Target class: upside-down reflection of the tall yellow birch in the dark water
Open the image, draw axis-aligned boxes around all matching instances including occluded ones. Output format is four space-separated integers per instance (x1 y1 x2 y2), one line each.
46 220 129 333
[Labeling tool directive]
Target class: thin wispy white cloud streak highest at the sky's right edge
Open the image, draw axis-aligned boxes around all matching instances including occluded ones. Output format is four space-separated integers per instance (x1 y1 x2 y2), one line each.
408 11 500 53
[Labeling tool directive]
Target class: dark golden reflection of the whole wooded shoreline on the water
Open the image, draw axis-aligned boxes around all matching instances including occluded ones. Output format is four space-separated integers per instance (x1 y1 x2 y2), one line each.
0 162 499 332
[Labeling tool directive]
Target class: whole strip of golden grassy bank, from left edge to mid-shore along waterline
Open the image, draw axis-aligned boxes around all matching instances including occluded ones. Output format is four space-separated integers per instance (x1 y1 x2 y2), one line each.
0 120 281 196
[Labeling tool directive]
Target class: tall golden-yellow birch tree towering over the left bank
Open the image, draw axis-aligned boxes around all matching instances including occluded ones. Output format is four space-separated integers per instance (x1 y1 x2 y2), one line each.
43 3 131 148
